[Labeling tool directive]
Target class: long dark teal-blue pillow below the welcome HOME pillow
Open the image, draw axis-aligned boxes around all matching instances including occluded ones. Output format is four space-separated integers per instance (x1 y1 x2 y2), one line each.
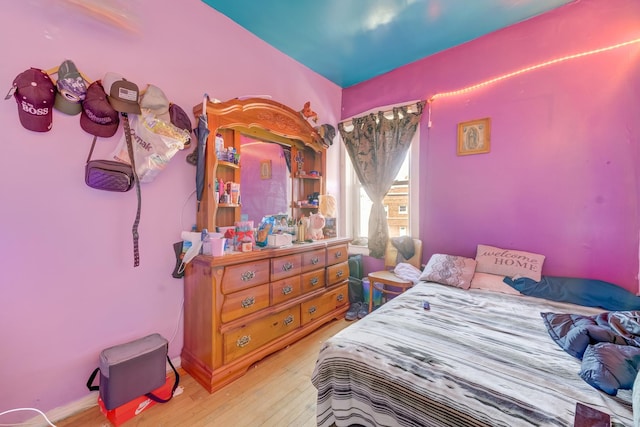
503 276 640 311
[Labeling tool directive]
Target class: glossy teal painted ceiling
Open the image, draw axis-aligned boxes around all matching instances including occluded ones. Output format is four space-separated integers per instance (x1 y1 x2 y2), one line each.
203 0 574 88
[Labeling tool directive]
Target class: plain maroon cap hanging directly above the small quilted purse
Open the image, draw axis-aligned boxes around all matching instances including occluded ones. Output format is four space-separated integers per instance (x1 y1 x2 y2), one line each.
80 80 120 138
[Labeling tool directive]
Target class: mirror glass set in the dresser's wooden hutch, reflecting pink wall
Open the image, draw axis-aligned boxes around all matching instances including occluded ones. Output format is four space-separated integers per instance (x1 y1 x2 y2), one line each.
240 135 292 226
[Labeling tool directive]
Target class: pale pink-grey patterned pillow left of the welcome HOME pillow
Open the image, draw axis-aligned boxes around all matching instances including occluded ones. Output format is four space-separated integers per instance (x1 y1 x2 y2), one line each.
420 254 476 289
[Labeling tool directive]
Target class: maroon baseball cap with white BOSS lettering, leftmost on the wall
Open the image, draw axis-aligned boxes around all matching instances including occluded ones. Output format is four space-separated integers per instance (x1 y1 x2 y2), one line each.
9 67 56 132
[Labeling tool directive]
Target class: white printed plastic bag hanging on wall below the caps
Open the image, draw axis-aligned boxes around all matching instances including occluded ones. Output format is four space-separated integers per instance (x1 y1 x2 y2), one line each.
113 111 190 182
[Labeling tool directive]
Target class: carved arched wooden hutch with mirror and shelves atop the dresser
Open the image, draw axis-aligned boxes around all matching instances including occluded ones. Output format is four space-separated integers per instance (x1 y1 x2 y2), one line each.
193 98 326 234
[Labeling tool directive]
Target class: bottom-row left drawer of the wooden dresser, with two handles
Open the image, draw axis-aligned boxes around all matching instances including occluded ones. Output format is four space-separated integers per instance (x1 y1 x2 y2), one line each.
223 305 300 363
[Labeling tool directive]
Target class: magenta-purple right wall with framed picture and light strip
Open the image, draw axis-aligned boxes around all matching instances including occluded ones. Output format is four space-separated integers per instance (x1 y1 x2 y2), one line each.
342 0 640 292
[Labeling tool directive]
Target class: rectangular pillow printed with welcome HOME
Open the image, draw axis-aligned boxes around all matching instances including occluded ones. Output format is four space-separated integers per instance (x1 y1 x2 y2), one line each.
476 245 545 282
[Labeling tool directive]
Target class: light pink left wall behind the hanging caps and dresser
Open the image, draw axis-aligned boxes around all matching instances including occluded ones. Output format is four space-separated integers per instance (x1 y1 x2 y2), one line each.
0 0 341 424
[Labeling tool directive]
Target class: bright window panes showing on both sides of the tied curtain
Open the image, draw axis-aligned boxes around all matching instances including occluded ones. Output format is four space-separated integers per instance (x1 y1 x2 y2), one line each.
344 130 420 246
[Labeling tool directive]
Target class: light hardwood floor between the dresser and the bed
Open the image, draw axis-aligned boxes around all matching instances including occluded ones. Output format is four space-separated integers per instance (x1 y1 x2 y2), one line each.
54 319 350 427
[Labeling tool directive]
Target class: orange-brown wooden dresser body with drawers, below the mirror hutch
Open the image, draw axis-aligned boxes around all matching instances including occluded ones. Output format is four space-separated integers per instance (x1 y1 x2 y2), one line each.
181 238 350 393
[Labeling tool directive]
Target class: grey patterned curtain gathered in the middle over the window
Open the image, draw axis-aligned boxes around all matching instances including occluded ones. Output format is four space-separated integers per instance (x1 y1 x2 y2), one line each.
338 101 425 258
